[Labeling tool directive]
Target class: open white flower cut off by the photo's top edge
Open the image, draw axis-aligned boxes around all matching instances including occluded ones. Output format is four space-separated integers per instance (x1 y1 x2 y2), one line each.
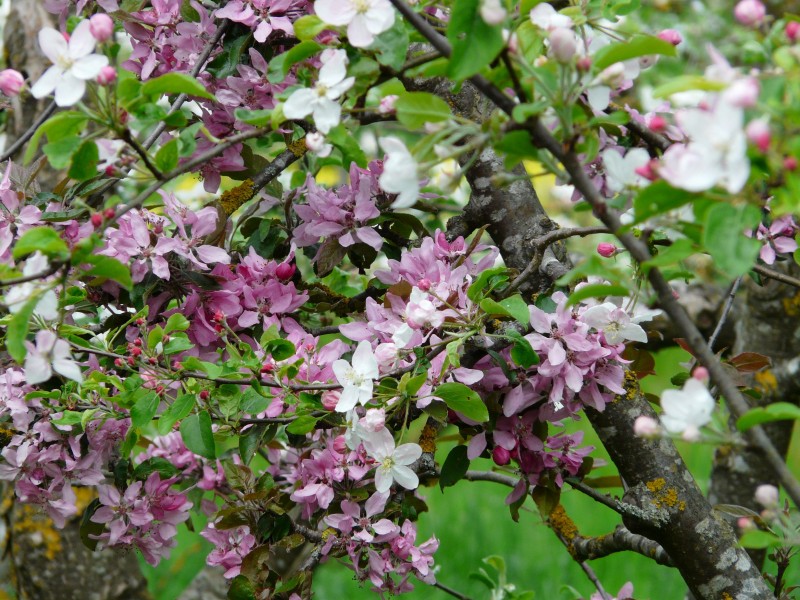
314 0 394 48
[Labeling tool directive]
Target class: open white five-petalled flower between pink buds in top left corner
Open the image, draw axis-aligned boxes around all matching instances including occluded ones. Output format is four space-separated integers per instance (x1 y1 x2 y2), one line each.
31 20 108 106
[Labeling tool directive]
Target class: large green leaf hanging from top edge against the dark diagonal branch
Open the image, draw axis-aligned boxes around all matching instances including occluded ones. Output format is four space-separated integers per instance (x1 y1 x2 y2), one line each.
447 0 505 81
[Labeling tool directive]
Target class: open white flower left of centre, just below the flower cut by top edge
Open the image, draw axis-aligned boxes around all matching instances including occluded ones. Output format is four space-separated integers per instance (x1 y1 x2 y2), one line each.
283 50 355 133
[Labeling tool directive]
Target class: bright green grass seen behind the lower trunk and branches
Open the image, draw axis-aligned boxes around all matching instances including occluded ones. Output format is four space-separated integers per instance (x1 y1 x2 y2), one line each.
144 349 800 600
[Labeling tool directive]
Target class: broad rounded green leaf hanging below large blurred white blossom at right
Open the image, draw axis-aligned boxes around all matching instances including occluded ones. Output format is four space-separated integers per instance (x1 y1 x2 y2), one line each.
703 203 761 277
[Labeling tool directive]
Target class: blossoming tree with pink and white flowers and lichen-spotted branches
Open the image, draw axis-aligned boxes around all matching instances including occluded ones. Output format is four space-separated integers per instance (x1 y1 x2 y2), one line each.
0 0 800 600
